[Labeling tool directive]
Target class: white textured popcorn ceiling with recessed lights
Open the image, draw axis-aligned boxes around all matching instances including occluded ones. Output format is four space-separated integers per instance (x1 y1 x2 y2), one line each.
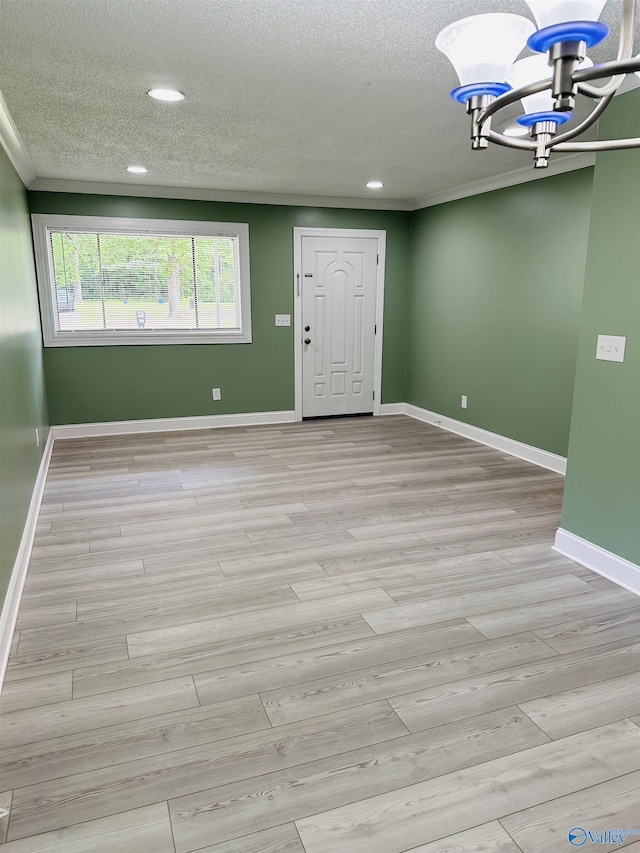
0 0 638 200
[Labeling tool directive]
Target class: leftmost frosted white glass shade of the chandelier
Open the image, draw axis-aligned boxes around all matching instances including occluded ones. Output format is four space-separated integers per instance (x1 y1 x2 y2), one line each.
436 12 535 86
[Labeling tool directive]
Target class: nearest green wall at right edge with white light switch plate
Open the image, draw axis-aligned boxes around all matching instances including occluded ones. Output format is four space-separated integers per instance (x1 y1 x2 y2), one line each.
562 90 640 563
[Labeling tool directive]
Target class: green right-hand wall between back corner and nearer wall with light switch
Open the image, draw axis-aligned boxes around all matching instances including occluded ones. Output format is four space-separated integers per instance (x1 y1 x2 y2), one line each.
407 169 593 456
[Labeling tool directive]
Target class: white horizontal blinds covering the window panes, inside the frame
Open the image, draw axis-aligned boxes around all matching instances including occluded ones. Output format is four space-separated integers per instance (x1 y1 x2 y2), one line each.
49 230 241 332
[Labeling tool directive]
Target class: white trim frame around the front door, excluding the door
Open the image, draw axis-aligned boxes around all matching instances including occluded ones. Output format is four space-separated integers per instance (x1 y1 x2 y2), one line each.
293 228 387 421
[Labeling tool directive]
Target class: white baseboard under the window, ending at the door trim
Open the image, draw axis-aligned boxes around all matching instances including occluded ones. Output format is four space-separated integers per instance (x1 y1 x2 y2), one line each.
51 411 295 438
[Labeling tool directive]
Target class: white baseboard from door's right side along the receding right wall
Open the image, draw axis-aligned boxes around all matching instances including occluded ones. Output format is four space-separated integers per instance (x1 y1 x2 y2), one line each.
381 403 567 474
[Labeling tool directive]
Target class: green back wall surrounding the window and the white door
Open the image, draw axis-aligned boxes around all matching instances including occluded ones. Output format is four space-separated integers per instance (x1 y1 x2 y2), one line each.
29 192 410 424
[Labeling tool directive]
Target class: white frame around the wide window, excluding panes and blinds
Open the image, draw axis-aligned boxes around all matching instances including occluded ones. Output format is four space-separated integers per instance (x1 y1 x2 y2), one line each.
31 213 252 347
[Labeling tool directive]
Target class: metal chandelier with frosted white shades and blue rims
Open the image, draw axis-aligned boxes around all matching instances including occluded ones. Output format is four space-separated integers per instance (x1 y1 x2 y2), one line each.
436 0 640 169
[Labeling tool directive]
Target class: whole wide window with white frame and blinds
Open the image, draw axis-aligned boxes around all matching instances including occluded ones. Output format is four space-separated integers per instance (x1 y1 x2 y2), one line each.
32 214 251 346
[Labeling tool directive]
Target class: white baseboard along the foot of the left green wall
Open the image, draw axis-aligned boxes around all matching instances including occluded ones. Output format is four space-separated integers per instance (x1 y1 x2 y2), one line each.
0 432 54 692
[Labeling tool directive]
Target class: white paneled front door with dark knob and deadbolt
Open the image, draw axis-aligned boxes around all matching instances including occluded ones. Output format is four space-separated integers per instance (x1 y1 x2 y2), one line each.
300 235 378 418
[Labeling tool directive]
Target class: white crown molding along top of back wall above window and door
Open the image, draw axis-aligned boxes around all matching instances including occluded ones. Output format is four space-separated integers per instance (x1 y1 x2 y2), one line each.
29 178 412 211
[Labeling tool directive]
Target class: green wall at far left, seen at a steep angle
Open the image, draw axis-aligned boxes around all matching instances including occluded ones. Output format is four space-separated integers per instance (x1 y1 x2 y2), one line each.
0 147 47 607
